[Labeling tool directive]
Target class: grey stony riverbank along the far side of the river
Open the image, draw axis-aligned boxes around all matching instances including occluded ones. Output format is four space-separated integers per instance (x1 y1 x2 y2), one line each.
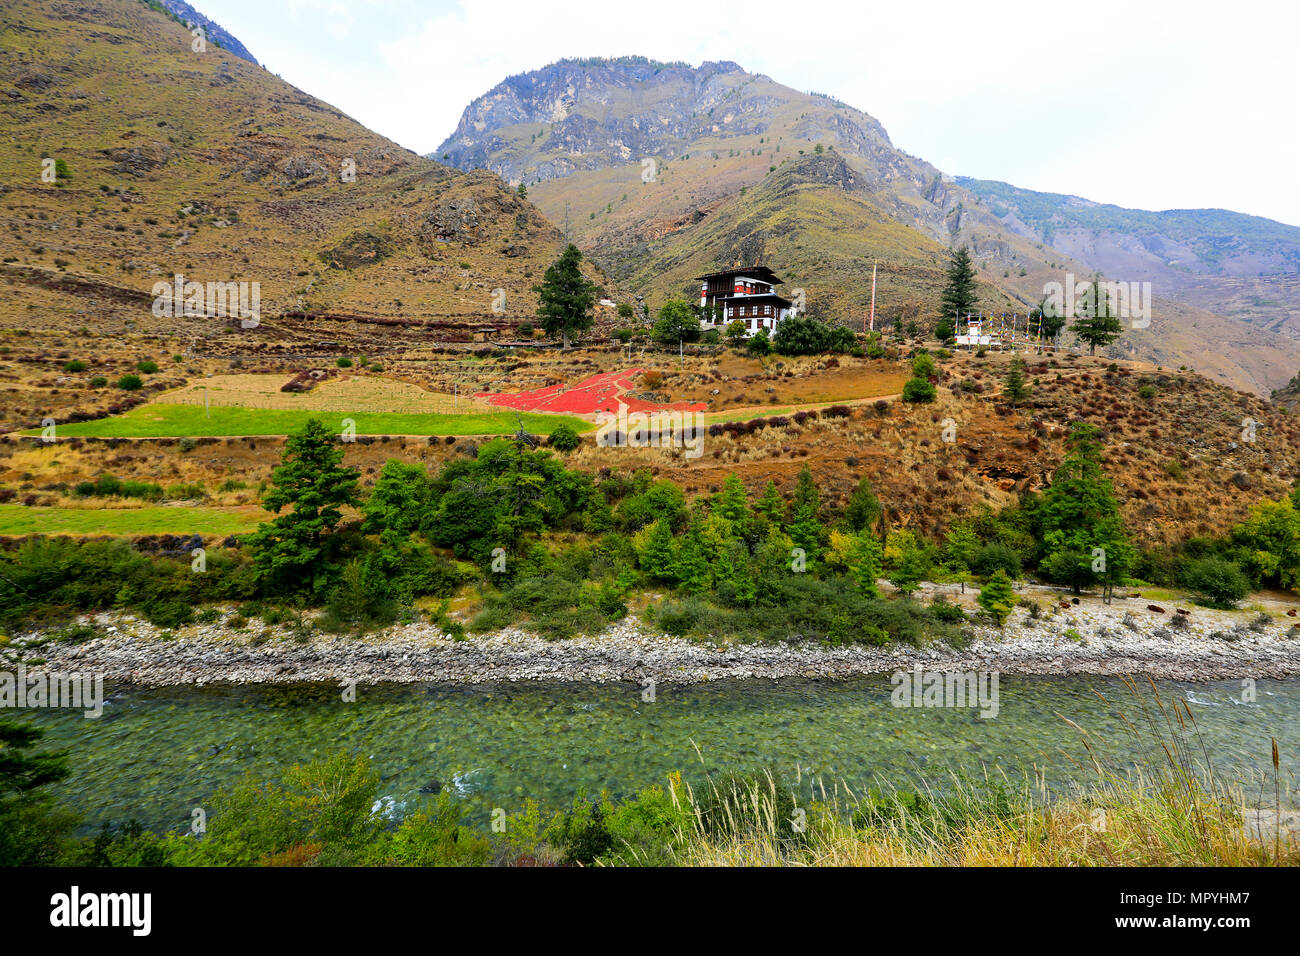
15 600 1300 685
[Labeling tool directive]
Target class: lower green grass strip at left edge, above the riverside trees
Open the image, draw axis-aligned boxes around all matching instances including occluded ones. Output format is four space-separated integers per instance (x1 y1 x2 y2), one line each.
0 505 270 536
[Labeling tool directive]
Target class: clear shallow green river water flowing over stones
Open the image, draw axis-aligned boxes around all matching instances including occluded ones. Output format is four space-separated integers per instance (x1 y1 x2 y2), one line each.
29 675 1300 830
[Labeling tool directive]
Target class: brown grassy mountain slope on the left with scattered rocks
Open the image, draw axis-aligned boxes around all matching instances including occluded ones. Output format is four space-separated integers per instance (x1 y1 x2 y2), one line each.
0 0 585 351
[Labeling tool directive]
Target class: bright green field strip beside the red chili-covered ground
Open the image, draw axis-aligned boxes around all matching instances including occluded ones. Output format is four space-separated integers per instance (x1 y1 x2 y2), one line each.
25 403 595 438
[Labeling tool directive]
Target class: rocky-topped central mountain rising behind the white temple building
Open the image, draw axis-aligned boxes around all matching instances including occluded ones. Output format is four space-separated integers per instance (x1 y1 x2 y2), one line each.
433 57 1300 393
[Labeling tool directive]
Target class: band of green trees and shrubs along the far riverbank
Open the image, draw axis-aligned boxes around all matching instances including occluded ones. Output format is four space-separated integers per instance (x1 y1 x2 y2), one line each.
0 411 1300 646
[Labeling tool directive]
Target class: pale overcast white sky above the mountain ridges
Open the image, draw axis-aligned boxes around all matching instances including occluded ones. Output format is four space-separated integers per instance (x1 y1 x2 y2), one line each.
191 0 1300 225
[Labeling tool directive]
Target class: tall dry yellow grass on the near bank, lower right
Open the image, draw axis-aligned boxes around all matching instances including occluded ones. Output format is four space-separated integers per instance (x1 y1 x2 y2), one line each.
650 680 1300 866
